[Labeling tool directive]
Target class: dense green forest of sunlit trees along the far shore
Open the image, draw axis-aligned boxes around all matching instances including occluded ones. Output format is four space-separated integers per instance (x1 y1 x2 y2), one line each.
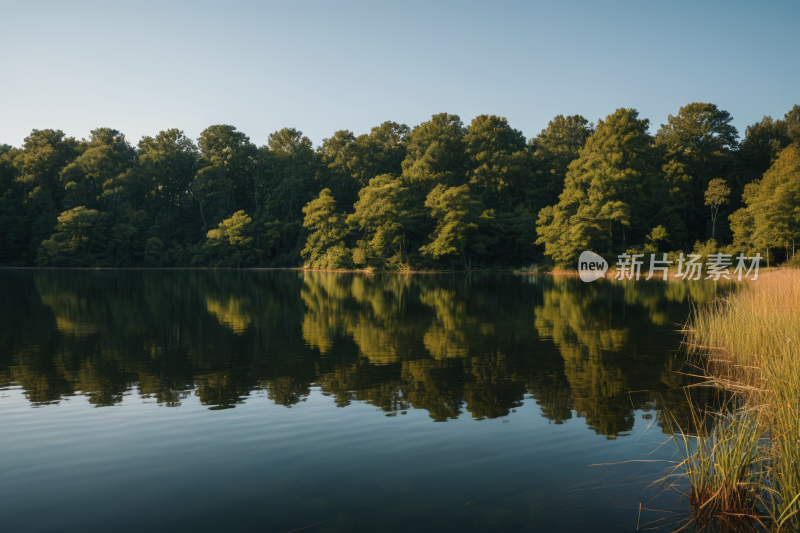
0 103 800 271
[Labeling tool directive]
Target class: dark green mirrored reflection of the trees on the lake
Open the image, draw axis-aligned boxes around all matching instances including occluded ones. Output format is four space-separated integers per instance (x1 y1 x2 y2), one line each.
0 270 727 438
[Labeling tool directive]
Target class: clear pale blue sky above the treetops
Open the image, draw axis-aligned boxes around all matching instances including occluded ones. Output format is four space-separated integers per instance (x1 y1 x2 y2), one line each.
0 0 800 146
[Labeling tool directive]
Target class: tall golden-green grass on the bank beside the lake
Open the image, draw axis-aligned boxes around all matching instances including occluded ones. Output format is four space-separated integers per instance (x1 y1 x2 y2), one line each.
688 269 800 528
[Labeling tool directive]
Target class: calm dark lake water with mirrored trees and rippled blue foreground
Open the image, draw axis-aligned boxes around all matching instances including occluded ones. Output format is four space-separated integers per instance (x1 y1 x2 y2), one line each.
0 270 719 533
